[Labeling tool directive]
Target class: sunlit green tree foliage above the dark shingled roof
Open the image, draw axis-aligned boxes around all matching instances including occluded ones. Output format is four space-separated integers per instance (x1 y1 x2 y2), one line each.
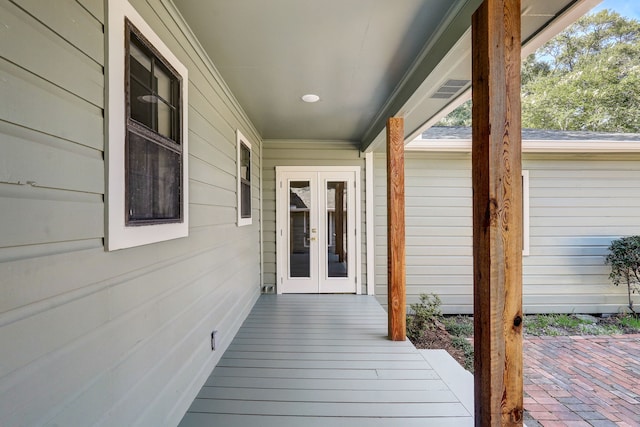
439 10 640 132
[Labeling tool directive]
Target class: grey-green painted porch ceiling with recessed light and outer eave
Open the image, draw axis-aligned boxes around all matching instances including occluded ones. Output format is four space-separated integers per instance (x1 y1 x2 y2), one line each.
174 0 598 148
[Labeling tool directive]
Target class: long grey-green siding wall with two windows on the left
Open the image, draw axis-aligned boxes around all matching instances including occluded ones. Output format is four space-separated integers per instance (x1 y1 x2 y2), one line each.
0 0 262 426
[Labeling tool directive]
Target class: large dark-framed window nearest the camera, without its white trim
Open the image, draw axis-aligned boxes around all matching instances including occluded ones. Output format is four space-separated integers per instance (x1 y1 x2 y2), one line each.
125 20 184 226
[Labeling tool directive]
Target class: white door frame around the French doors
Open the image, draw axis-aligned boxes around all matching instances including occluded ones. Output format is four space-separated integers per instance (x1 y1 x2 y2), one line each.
275 166 362 295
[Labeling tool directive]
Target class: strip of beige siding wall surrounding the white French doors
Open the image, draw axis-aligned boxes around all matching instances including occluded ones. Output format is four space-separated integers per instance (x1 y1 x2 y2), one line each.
262 140 367 294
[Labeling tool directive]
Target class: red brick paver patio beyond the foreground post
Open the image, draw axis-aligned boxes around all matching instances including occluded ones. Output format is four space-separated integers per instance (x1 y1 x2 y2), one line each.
524 335 640 427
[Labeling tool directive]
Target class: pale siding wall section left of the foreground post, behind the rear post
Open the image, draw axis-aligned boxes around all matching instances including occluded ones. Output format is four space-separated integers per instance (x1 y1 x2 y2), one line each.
375 152 473 312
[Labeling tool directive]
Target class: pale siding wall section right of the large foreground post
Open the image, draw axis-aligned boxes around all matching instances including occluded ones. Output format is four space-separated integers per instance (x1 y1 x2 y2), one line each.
523 154 640 312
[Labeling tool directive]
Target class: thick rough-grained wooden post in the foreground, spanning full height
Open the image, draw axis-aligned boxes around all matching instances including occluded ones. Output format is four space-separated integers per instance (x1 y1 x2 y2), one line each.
472 0 523 426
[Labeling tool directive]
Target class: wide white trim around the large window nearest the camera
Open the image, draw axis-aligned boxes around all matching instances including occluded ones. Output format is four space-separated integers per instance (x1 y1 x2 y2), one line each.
105 0 189 251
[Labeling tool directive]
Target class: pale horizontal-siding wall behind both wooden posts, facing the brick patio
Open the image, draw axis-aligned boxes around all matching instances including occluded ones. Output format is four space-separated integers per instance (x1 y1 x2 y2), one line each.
374 151 640 313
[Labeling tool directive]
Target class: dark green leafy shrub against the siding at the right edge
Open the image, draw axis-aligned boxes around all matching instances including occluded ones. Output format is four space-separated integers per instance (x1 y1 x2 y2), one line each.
605 236 640 315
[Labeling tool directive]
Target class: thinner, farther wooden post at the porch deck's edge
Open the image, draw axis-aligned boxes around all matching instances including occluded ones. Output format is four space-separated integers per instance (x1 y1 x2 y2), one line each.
387 117 407 341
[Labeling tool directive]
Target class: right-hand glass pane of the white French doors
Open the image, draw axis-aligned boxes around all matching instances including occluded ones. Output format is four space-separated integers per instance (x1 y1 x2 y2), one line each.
326 181 349 277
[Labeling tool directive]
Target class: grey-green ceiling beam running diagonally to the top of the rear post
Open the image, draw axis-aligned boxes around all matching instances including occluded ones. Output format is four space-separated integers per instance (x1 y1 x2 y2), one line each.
360 0 482 152
